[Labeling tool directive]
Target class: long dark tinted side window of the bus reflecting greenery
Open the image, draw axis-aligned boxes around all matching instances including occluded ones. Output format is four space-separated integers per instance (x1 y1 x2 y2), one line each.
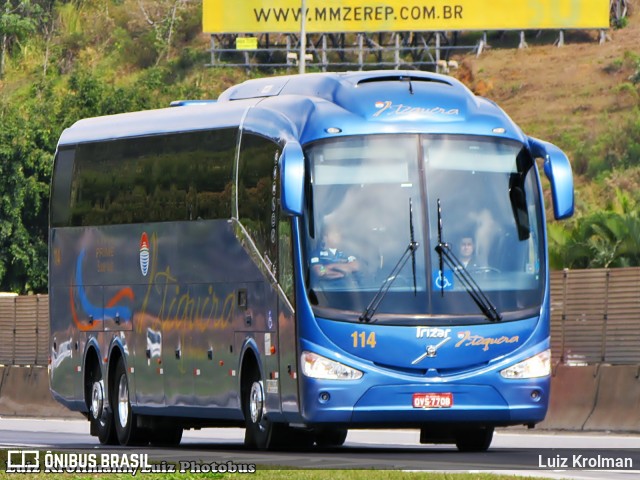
71 129 236 226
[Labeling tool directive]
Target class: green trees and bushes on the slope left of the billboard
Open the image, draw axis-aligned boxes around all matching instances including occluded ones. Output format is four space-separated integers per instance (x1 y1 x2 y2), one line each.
0 0 228 293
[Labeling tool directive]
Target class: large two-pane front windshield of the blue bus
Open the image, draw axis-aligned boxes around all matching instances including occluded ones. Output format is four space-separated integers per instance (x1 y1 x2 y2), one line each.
305 134 545 325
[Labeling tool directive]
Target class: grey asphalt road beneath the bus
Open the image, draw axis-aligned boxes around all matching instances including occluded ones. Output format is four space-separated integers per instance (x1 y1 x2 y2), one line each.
0 417 640 480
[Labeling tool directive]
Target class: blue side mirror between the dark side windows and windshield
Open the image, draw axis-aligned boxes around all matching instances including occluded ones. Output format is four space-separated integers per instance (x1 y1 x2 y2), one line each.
280 141 304 215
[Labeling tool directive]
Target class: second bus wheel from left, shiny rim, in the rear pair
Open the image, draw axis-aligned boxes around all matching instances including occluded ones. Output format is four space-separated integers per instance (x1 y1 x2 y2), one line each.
111 358 148 445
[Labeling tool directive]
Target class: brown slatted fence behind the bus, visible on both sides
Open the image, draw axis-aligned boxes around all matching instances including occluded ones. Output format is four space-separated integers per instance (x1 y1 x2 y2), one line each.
0 268 640 366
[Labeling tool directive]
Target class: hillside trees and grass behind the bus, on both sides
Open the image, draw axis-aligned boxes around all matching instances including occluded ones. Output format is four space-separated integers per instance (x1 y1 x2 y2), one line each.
0 0 640 293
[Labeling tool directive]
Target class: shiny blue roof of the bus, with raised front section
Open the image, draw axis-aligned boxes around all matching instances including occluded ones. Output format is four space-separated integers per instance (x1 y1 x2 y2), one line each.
59 70 526 145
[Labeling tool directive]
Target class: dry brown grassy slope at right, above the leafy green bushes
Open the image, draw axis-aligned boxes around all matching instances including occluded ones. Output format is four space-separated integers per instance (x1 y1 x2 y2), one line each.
454 14 640 214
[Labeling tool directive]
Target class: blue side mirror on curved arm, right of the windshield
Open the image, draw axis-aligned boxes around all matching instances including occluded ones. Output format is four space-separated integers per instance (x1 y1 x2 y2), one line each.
529 138 573 220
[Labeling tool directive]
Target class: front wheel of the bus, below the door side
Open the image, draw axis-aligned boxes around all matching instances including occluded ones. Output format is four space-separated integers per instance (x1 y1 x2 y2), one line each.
243 370 284 450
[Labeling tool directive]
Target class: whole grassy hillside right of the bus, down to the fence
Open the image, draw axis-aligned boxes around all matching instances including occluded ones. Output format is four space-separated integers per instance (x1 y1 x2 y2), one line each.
454 8 640 268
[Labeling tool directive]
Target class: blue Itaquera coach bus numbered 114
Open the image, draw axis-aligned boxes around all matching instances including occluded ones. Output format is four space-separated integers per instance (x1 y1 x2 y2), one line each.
49 71 573 451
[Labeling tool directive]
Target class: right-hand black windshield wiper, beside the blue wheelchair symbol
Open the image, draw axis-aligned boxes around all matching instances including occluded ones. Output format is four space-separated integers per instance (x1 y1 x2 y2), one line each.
436 199 502 322
